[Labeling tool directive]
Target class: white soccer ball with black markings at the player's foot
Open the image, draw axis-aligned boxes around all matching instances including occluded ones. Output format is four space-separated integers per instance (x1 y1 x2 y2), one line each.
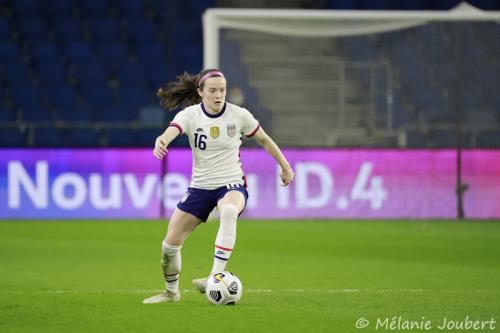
205 272 243 305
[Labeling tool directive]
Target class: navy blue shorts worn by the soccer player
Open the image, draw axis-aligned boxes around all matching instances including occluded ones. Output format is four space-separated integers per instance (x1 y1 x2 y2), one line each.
177 185 248 222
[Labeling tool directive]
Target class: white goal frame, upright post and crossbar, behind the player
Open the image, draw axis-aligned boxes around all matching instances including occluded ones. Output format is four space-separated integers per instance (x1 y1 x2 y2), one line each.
203 6 500 68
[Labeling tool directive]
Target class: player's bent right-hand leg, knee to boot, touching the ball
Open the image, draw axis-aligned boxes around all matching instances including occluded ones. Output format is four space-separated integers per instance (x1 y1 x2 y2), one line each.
193 190 246 293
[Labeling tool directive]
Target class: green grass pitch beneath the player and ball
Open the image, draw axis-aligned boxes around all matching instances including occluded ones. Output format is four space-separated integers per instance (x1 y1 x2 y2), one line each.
0 220 500 333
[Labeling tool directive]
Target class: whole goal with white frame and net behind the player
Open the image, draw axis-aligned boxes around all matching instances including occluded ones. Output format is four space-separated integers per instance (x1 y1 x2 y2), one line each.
204 4 500 148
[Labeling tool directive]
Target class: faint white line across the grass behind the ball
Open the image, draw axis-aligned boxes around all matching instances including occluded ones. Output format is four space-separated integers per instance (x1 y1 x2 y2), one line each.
0 289 498 295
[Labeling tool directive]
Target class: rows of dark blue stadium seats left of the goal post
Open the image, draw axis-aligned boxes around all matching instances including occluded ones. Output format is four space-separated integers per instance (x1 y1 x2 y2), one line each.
0 0 214 147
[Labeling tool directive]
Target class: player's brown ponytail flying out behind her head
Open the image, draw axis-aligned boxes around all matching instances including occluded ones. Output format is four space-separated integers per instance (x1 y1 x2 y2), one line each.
156 69 222 111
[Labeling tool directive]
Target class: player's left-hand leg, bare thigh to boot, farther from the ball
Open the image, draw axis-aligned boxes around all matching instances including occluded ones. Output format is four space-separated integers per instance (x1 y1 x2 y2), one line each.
143 208 201 304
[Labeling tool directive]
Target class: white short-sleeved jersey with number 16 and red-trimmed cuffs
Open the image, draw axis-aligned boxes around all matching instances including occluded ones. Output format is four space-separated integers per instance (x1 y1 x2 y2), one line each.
170 102 260 190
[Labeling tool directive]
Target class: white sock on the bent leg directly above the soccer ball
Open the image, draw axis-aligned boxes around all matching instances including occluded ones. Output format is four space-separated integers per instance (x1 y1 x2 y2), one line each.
212 204 239 274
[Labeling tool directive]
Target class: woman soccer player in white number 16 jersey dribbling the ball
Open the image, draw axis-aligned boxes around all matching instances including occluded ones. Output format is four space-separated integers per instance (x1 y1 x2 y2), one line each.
144 69 294 304
